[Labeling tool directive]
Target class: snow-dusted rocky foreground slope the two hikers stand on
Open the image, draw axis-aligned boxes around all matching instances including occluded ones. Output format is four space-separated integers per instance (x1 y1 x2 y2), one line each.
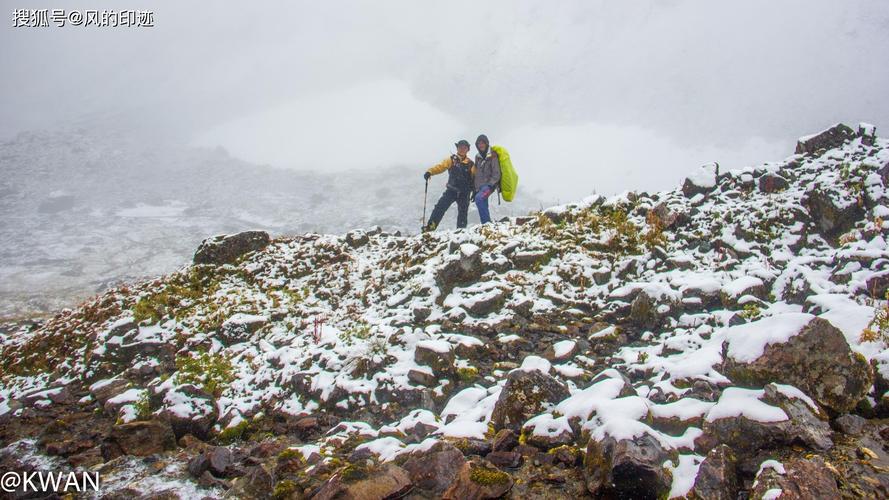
0 125 889 499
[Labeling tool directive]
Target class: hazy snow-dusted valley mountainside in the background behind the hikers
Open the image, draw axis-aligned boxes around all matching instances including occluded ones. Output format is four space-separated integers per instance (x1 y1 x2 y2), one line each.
0 129 541 318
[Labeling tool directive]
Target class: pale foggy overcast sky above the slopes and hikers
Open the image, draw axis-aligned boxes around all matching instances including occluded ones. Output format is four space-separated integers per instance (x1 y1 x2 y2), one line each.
0 0 889 201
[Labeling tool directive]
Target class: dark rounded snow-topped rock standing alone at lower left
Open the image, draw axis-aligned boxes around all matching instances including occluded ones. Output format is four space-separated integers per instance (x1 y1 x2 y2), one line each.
161 384 219 439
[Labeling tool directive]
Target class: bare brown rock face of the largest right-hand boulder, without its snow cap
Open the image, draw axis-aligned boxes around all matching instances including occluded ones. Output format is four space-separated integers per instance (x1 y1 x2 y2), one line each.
724 318 873 413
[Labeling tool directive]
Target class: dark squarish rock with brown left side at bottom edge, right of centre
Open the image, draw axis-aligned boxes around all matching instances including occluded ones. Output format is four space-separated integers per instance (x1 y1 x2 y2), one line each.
583 434 676 499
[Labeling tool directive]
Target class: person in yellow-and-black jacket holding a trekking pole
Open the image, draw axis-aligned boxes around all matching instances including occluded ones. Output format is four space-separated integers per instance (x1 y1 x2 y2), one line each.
423 139 473 232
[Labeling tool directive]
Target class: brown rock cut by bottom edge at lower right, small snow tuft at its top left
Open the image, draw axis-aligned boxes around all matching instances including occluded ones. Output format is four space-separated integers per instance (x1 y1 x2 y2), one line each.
750 455 842 500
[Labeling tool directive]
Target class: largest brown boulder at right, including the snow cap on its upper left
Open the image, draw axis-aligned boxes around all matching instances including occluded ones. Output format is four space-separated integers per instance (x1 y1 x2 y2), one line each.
723 314 873 413
